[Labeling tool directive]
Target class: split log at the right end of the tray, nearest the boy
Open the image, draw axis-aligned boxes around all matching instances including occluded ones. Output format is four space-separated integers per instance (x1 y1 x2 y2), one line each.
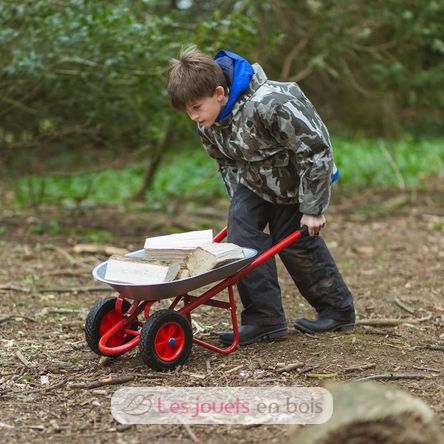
186 242 245 276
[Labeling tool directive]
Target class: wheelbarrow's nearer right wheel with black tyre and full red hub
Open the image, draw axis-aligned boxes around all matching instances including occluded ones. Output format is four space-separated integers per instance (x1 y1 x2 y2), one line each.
139 310 193 371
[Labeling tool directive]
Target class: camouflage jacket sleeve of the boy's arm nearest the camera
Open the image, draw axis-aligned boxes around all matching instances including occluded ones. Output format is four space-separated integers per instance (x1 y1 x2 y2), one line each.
264 99 333 215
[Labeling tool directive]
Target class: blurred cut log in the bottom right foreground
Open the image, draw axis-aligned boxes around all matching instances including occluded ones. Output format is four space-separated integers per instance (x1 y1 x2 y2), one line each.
289 382 444 444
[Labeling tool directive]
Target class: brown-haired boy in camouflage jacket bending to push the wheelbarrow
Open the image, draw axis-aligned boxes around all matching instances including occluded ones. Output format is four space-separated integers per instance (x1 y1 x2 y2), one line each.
168 47 355 345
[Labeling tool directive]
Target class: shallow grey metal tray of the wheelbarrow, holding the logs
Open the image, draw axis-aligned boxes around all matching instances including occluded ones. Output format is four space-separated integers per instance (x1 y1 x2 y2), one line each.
92 248 257 301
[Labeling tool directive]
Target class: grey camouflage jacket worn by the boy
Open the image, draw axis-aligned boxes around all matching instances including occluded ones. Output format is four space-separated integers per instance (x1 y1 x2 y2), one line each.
198 63 334 215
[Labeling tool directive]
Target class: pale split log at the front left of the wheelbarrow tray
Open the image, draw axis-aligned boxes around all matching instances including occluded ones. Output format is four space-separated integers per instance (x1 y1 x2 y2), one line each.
105 255 180 285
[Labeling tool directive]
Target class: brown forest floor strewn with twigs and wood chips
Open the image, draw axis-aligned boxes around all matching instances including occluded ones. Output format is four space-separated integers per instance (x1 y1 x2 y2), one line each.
0 192 444 443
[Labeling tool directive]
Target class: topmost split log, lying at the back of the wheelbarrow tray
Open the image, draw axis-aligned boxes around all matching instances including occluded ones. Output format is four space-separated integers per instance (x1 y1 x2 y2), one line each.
145 230 213 265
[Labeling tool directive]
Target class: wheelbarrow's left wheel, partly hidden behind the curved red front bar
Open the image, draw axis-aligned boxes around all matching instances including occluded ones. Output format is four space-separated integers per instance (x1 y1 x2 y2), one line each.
85 297 138 356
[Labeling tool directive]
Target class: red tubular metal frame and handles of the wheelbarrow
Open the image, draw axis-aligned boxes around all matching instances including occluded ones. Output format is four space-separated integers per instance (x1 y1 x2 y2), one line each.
98 226 308 356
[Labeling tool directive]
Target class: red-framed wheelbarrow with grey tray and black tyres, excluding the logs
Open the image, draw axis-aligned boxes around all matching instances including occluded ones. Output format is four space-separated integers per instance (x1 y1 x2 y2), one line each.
85 226 308 371
